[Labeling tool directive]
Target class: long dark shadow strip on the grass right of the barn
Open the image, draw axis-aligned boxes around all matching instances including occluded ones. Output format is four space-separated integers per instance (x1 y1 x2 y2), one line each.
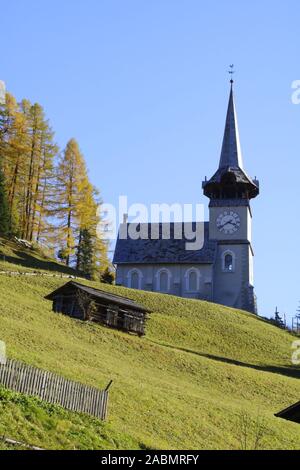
148 339 300 379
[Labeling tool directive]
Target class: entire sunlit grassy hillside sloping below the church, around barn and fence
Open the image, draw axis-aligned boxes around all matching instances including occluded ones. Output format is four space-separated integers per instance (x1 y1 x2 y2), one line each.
0 241 300 449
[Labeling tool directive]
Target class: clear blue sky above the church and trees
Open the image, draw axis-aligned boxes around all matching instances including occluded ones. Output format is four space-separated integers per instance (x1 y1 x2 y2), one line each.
0 0 300 322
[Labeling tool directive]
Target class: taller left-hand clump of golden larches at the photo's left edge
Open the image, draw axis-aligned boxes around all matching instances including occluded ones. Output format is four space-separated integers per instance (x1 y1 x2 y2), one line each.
0 94 58 241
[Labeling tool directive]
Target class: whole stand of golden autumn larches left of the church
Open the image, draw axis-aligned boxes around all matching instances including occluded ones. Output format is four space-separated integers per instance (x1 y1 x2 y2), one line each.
0 87 109 278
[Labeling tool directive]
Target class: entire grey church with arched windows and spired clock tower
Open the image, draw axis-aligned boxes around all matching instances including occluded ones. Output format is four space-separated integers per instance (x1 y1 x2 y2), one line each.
113 80 259 313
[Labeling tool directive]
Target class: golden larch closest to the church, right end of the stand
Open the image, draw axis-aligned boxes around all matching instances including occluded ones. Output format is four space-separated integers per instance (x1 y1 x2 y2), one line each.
57 139 108 278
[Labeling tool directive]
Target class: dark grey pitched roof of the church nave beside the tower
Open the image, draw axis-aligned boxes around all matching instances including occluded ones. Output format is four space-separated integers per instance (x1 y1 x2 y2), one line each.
113 222 217 264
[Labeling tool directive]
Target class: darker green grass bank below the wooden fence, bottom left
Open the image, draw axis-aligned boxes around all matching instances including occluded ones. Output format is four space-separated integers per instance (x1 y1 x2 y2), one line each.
0 387 139 450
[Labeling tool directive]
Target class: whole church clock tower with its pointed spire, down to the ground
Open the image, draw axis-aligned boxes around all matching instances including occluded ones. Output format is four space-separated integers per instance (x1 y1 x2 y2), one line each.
202 80 259 313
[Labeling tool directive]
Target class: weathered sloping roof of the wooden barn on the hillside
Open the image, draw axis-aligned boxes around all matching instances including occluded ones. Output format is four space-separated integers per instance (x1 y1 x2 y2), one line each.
45 281 150 312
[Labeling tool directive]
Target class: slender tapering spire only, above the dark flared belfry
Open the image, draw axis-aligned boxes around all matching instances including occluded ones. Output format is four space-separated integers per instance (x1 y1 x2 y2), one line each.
219 83 243 169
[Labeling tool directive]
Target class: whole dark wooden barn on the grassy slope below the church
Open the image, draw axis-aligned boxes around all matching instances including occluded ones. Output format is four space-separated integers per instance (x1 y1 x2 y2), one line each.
45 281 150 336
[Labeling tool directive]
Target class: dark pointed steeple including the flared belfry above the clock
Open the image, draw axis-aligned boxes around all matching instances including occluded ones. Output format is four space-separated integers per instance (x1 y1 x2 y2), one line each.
202 79 259 200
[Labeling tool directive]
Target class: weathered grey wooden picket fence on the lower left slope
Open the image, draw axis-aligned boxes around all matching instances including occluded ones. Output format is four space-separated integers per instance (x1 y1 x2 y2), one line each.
0 359 108 420
